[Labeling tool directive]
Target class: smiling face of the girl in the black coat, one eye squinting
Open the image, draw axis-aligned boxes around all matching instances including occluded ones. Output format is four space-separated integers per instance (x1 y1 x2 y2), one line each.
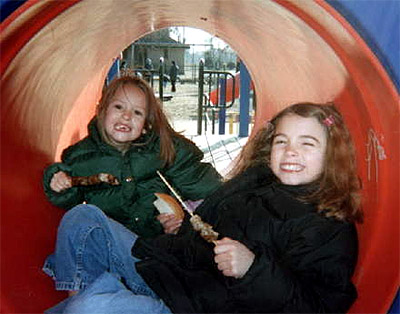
270 114 327 185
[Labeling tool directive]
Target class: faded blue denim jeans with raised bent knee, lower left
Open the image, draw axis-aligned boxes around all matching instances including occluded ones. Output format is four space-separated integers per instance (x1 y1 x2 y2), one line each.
43 204 171 314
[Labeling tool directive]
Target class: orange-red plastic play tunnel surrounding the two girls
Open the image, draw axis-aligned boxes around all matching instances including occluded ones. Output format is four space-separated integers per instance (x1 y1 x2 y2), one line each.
0 0 400 313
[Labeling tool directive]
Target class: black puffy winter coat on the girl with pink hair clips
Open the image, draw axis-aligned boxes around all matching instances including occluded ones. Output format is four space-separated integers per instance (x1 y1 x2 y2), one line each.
132 167 358 313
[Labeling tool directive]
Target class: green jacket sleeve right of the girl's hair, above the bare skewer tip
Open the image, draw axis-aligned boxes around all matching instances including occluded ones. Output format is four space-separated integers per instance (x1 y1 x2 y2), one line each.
165 139 221 200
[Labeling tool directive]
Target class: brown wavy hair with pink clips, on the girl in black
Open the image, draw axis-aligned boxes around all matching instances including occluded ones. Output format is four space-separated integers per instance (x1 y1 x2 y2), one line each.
229 103 362 222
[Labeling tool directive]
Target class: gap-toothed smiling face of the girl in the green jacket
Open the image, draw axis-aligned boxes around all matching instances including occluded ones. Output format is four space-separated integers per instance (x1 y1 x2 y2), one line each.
104 85 147 146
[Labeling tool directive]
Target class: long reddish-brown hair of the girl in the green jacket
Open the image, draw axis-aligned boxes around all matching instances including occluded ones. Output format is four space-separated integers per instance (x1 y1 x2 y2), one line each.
97 75 186 165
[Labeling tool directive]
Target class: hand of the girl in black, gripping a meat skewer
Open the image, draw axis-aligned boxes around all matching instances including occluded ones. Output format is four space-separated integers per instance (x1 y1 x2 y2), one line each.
214 238 255 279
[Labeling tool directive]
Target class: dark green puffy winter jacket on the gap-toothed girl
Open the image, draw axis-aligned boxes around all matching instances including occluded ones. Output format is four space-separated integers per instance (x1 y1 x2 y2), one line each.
43 119 221 237
